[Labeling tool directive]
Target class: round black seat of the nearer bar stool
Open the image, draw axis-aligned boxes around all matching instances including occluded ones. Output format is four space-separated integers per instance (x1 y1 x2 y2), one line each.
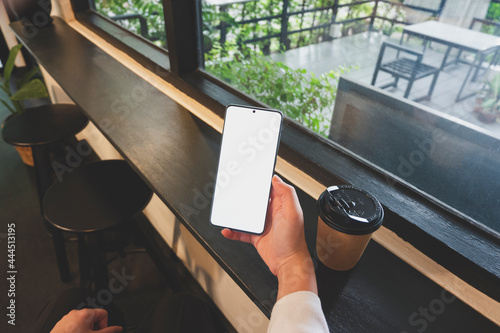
43 160 152 233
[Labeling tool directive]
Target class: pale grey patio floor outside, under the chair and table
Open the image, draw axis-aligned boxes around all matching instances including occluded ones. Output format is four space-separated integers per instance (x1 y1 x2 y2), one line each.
271 32 500 138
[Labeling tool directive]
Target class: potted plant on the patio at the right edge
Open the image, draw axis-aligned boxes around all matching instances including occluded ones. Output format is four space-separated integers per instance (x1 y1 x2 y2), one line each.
474 73 500 123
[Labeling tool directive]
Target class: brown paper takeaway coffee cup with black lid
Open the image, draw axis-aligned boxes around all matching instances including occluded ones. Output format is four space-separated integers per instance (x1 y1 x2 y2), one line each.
316 185 384 271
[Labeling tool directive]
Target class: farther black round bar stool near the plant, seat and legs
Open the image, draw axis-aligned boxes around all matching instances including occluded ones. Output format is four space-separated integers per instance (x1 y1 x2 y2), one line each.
2 104 88 281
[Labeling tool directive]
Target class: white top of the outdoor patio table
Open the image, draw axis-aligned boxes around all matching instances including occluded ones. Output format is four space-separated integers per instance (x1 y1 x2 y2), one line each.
404 21 500 52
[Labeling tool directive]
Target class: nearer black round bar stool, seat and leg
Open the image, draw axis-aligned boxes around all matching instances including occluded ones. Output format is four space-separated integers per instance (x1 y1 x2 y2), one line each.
43 160 152 290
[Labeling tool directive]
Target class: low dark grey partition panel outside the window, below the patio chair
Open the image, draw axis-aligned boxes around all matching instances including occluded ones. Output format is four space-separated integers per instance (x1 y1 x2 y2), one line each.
329 78 500 236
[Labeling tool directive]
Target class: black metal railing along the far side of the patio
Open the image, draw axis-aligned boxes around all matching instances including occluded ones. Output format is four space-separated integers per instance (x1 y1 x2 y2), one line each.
204 0 446 52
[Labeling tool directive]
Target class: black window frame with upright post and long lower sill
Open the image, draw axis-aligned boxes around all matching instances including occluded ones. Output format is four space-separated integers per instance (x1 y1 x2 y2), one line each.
67 0 500 299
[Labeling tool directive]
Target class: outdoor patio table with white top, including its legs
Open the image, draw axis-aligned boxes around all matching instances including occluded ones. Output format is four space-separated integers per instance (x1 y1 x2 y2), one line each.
401 21 500 102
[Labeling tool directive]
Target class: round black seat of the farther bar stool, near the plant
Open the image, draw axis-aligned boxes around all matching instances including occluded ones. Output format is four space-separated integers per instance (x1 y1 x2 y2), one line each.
2 104 88 147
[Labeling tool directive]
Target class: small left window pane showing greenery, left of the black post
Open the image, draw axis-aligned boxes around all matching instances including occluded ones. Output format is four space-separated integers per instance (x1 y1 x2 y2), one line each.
91 0 167 49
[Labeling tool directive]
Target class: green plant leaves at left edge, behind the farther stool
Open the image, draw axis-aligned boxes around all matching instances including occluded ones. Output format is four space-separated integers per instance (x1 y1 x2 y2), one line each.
0 44 49 114
